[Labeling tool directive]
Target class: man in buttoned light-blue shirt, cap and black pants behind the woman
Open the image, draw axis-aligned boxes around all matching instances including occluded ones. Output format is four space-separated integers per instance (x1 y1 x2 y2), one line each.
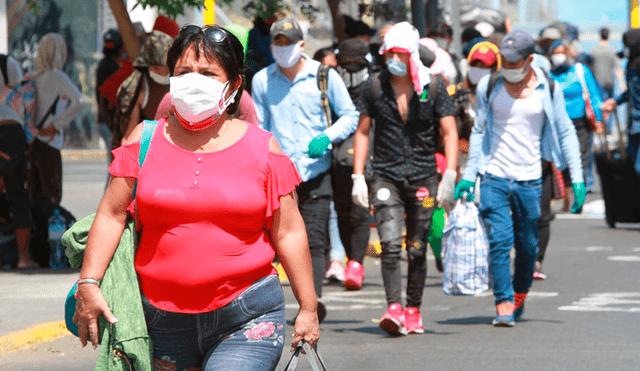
251 18 359 320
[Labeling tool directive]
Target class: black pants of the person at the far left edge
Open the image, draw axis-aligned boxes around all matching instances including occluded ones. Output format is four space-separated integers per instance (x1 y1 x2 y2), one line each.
0 124 32 228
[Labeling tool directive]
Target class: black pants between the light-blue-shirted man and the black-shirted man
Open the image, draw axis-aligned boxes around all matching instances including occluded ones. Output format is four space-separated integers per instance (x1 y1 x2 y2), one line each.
331 164 371 263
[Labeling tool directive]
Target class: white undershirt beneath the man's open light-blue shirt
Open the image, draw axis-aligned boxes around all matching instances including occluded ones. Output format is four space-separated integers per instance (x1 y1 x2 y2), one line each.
487 87 544 181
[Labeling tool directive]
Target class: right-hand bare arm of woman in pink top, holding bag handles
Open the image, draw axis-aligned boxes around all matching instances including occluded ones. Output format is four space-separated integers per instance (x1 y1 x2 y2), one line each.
269 137 320 349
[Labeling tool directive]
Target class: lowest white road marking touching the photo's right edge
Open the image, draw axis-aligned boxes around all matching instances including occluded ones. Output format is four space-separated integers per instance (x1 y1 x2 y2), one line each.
558 292 640 313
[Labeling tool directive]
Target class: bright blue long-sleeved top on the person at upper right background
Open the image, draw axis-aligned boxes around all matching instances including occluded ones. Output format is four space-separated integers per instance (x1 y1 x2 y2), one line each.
551 63 602 121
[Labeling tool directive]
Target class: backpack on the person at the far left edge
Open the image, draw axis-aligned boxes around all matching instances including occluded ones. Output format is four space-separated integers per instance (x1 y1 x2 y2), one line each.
0 55 37 143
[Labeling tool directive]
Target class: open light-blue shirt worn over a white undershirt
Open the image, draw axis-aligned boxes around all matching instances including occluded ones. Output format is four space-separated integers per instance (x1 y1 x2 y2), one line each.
463 67 584 183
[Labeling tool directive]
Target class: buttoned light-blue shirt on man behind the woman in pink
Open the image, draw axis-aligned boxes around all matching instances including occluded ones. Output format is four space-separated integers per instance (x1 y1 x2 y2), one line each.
251 54 360 182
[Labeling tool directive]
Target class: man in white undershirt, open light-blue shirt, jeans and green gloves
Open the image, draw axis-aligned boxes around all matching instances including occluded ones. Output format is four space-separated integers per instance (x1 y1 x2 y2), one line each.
455 31 586 327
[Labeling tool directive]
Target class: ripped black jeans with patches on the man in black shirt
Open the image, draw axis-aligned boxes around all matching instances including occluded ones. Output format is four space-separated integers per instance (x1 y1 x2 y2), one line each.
371 175 438 308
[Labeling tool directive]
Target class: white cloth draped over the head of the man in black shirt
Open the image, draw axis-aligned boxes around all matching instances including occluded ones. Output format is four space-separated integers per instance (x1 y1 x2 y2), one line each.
378 22 431 94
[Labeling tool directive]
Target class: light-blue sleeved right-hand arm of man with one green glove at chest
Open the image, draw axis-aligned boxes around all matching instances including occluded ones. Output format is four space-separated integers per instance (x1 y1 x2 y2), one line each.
324 69 360 143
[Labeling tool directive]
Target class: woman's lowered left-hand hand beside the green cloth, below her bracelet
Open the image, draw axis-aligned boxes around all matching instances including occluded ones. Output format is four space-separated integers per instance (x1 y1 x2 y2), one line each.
73 283 118 349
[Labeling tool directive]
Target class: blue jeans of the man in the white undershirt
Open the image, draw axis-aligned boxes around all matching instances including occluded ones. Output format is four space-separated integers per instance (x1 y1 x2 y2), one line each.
480 174 542 304
